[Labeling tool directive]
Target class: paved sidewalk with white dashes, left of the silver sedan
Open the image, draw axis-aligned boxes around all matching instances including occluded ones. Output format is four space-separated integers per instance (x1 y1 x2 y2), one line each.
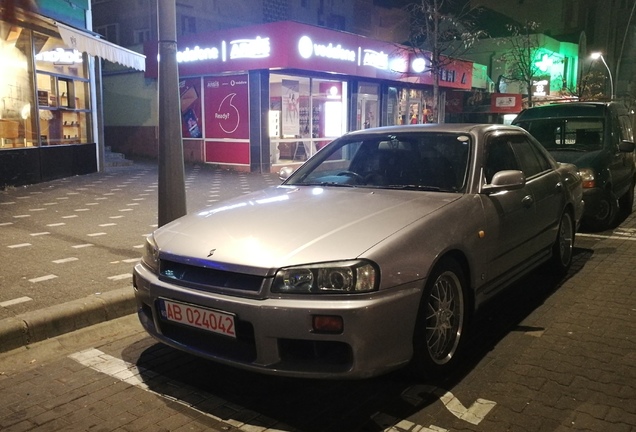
0 162 280 352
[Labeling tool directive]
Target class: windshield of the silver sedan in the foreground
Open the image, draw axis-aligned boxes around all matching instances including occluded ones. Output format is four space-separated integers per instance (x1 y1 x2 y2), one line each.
285 132 471 192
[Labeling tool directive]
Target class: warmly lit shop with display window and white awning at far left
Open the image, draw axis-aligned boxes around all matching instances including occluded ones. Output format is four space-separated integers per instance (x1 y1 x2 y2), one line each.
0 4 145 187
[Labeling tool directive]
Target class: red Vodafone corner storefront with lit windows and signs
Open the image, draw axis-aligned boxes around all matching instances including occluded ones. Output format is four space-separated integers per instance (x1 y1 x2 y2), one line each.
145 21 472 171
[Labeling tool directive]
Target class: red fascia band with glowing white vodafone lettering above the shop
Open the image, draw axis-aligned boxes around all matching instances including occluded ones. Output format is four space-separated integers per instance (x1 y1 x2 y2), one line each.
144 21 472 90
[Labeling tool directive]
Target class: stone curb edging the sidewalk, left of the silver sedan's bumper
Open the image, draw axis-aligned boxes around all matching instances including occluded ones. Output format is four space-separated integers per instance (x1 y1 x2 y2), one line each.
0 287 136 353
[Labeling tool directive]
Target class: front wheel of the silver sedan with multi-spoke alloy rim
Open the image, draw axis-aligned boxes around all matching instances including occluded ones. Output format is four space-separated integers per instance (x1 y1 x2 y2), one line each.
411 258 468 379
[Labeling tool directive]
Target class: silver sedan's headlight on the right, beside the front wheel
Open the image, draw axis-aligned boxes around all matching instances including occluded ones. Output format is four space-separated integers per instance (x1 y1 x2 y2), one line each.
272 260 380 294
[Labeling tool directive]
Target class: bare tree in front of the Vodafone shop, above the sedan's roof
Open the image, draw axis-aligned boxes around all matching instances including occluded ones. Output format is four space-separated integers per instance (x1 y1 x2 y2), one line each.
406 0 486 122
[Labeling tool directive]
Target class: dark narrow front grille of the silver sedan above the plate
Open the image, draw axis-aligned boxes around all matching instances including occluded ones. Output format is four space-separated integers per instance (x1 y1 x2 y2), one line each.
160 260 265 293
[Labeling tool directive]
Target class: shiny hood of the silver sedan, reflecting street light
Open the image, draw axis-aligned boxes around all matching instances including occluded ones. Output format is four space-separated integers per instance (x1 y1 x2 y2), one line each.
154 186 462 274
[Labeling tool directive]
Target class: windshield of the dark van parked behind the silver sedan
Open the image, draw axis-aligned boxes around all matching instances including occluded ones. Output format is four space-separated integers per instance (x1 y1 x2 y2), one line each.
519 118 603 152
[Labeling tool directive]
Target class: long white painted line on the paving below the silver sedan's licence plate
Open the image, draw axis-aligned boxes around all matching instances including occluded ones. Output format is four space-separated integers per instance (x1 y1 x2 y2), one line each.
69 348 282 432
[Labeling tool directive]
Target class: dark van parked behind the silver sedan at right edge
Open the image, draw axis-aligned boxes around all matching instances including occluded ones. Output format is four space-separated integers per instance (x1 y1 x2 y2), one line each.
513 102 636 231
